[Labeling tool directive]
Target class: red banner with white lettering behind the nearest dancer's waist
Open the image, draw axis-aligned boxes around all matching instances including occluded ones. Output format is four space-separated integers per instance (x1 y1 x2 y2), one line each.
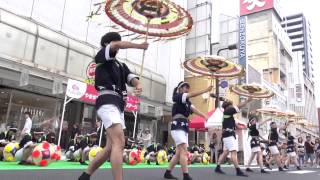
80 85 140 111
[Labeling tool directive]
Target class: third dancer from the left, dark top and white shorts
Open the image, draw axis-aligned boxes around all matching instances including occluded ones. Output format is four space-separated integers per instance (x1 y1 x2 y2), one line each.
215 98 252 177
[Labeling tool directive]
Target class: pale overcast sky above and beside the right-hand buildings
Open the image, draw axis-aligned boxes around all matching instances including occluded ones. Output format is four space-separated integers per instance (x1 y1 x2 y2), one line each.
219 0 320 107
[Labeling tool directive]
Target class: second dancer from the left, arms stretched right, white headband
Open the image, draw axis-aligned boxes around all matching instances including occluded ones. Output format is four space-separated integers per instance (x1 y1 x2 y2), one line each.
164 82 212 180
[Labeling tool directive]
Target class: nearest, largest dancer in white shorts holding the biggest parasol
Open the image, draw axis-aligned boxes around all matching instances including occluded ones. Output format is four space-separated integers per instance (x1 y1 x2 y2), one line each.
79 32 149 180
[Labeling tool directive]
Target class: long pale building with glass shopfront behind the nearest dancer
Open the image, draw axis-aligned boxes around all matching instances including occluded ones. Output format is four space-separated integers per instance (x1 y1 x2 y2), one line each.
0 0 185 145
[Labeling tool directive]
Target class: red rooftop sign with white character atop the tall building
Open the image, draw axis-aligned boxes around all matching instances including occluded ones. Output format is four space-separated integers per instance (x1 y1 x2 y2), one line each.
240 0 274 16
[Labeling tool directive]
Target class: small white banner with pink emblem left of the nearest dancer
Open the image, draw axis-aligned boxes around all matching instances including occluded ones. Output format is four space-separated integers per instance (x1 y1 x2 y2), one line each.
66 79 87 99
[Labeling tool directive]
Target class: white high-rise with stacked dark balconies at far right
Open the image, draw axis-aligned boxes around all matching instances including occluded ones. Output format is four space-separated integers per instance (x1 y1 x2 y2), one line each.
282 14 318 126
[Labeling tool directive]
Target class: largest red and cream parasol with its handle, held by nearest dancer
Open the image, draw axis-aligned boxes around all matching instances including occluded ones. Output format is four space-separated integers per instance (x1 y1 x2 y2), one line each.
105 0 193 77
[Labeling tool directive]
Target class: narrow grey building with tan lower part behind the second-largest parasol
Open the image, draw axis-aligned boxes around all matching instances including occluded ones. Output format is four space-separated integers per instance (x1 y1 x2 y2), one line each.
182 0 213 145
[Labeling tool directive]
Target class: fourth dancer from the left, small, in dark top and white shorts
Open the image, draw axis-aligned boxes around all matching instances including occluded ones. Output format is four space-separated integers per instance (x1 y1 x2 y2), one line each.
246 115 269 173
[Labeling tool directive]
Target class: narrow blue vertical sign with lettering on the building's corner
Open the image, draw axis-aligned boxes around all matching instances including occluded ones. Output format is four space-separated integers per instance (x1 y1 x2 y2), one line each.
239 16 247 83
